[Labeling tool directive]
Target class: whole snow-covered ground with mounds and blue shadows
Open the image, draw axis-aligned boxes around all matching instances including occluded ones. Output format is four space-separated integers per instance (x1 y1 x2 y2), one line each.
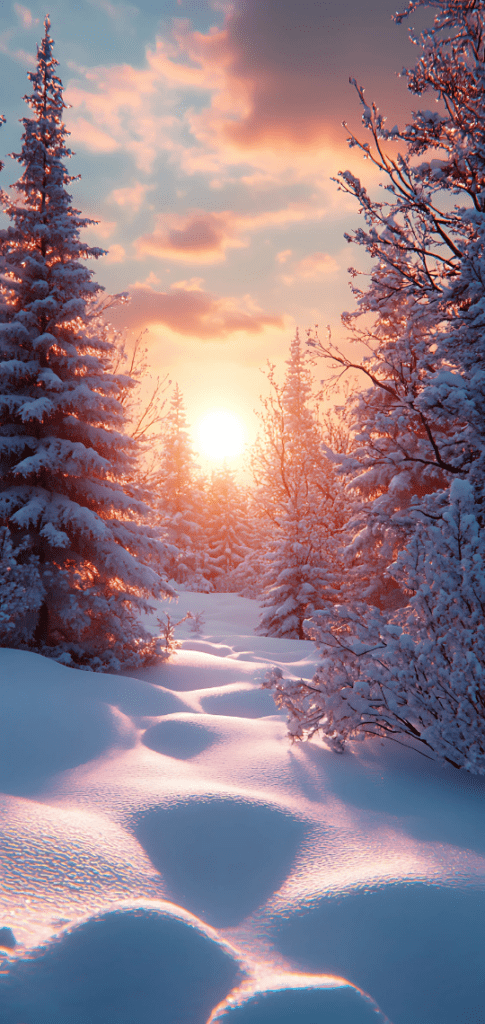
0 593 485 1024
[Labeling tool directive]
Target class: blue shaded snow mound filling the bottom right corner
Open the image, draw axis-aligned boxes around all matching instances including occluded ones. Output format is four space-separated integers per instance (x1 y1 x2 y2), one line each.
270 882 485 1024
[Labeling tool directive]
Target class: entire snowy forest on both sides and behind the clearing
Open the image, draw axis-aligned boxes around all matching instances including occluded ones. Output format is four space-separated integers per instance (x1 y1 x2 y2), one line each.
0 0 485 774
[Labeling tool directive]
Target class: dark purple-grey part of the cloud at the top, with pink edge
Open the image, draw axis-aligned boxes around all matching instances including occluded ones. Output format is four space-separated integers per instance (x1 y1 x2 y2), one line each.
169 0 410 158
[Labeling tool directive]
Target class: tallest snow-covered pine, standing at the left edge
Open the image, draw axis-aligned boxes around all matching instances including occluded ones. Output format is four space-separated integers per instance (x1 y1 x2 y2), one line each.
0 18 171 669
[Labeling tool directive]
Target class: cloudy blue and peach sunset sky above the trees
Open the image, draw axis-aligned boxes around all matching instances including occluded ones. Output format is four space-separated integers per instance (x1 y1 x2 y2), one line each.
0 0 429 464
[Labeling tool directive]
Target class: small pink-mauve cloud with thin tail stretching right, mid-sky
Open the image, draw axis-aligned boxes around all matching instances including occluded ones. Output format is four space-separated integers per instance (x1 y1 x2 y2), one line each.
135 202 327 263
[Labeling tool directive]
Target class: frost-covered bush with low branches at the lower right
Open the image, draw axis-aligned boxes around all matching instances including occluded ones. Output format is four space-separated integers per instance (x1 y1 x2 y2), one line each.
266 480 485 774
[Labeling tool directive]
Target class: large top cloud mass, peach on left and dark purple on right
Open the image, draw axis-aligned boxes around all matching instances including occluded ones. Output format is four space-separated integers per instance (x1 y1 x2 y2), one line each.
61 0 412 187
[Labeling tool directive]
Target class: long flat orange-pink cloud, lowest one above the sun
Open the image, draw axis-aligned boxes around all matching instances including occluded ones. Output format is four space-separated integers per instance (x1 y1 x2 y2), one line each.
108 282 283 341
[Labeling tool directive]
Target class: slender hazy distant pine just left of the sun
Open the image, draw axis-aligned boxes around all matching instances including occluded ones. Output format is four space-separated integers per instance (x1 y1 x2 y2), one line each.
153 384 212 591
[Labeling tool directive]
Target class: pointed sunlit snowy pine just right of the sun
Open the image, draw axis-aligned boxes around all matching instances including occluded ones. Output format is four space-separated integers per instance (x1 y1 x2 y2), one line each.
252 333 345 639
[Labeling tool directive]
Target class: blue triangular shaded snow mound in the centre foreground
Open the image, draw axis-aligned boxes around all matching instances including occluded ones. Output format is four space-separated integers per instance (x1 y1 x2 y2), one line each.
133 796 306 928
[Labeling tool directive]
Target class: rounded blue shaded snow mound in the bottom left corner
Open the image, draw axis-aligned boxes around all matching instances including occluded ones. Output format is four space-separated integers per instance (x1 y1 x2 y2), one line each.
0 905 243 1024
